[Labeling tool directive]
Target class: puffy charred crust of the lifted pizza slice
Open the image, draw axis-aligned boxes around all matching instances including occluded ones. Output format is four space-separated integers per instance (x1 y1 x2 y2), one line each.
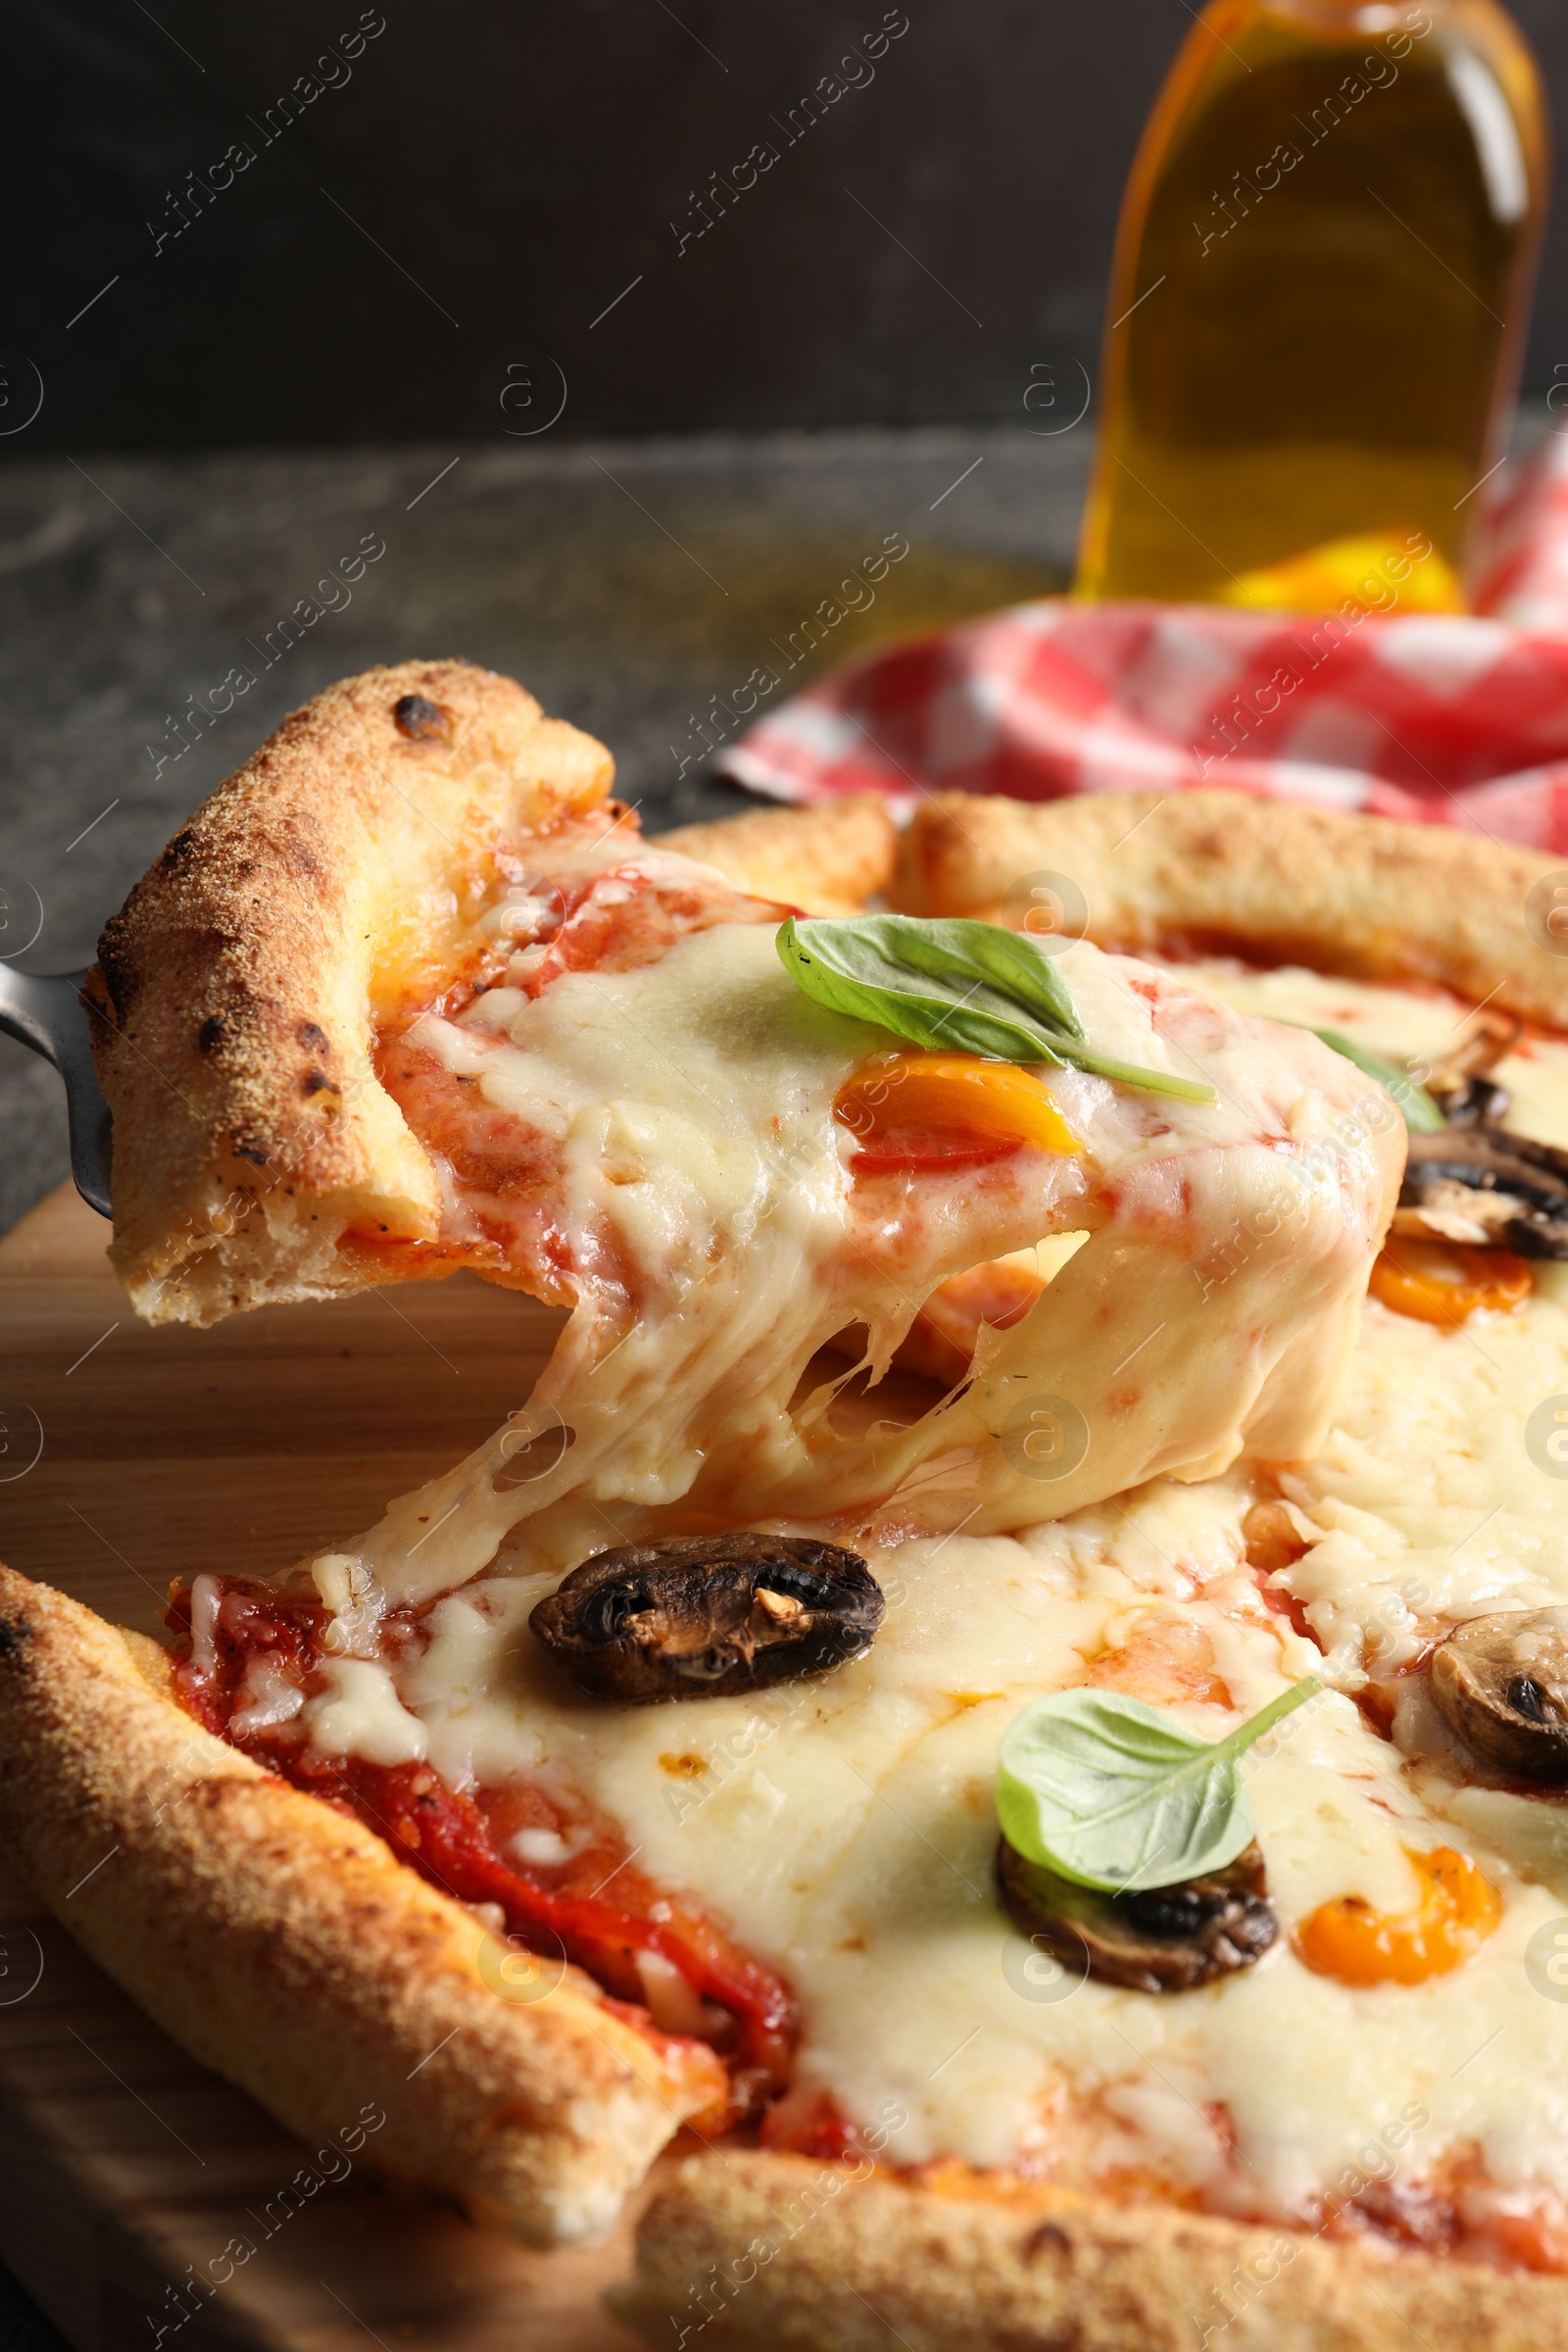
87 661 613 1324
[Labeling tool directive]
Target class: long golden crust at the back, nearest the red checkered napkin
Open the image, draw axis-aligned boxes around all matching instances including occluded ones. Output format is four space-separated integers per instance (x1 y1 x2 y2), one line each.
889 793 1568 1028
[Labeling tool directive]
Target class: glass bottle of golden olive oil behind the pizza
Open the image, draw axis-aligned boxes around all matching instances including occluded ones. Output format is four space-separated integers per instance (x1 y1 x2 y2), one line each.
1077 0 1546 610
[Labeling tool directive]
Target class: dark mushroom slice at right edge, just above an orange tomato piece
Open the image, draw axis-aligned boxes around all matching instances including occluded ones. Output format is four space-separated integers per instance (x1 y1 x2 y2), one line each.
1392 1124 1568 1258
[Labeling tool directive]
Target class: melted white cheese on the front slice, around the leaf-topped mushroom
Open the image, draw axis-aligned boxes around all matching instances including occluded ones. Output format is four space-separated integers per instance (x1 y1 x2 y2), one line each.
350 1477 1568 2216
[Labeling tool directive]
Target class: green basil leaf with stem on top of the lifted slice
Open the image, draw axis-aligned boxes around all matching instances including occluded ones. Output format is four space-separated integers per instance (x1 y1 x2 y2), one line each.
778 915 1215 1103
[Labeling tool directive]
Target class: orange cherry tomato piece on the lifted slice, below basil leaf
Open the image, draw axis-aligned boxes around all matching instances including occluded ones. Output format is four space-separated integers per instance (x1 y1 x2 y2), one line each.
832 1054 1084 1176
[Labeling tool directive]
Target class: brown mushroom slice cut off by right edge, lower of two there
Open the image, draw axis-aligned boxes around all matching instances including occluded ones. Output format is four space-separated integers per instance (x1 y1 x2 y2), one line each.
1432 1609 1568 1788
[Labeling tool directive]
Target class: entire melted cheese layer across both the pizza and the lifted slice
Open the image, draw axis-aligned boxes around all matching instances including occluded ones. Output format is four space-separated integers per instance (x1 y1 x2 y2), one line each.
301 931 1568 2218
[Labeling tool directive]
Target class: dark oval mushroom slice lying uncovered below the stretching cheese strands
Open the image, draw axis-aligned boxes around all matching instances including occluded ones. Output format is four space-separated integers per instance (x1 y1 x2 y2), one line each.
529 1534 884 1703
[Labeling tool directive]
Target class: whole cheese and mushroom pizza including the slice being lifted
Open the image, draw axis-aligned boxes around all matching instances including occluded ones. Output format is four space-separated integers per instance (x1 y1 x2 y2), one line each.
0 663 1568 2352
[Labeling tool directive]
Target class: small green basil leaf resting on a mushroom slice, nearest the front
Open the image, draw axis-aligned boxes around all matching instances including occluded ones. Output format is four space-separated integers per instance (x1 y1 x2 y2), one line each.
997 1677 1321 1893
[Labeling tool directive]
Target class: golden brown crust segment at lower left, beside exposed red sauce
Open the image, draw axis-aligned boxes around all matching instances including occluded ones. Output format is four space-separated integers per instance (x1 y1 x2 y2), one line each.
0 1569 714 2246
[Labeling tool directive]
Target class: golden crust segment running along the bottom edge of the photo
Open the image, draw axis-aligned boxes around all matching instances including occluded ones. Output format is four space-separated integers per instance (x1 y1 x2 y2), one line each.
612 2150 1568 2352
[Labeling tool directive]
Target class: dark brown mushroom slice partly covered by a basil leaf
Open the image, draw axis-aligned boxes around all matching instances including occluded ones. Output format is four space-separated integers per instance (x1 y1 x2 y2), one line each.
997 1837 1279 1992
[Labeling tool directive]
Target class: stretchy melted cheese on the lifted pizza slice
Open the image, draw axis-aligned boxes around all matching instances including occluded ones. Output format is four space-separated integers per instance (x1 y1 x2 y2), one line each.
345 907 1398 1604
